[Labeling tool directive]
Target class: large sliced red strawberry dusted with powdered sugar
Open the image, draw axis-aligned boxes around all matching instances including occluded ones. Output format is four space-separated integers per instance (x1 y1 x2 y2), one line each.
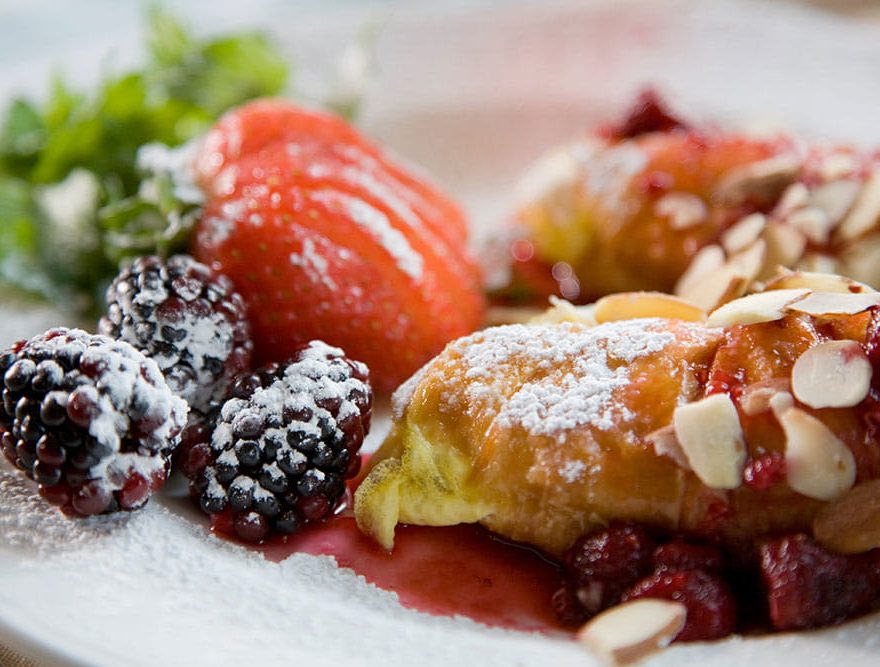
193 100 484 391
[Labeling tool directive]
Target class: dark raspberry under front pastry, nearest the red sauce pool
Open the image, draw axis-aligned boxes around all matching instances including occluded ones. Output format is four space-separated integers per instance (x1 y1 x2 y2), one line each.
563 522 654 618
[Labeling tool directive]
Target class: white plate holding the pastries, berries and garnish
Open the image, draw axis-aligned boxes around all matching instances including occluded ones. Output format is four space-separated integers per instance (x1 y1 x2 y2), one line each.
0 0 880 667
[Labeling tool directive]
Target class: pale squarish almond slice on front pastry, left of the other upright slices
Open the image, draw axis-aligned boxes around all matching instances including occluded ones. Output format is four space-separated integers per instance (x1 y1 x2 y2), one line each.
672 394 746 489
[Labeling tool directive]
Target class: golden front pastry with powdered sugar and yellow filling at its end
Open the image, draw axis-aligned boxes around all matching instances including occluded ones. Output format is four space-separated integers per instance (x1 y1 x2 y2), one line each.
356 314 880 553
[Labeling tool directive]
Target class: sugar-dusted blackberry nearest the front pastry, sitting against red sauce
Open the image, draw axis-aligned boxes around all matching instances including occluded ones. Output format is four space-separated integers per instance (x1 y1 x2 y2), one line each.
184 341 372 542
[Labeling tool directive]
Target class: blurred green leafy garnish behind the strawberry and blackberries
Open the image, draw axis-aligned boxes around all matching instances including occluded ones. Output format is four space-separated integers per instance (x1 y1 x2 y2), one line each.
0 8 289 310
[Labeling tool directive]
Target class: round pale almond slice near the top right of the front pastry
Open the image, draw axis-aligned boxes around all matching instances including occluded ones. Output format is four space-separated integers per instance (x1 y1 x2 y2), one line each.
791 340 873 409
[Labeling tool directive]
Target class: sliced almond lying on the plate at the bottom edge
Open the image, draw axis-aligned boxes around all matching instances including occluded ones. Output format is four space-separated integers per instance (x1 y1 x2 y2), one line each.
577 598 687 665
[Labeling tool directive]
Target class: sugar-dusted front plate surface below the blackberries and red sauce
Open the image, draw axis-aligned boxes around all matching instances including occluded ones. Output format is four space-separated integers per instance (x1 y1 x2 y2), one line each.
0 463 600 667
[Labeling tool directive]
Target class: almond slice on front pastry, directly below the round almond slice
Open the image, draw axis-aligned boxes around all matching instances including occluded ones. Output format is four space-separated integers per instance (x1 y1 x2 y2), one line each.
779 408 856 500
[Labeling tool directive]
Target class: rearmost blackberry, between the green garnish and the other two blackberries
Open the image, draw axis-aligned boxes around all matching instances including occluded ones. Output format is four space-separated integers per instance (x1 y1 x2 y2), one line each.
98 255 253 412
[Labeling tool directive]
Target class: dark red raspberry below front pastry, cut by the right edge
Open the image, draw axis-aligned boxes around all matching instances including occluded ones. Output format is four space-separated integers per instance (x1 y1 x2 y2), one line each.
760 534 880 630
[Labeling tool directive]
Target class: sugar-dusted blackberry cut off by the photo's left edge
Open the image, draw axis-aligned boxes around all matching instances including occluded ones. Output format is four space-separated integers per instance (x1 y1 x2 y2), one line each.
0 328 187 516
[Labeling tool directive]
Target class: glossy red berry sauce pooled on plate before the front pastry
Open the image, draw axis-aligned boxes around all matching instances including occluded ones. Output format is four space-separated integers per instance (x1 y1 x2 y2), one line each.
212 478 568 634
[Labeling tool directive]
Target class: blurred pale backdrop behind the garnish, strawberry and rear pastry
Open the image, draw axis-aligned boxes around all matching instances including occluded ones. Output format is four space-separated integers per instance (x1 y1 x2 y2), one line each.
0 0 880 338
